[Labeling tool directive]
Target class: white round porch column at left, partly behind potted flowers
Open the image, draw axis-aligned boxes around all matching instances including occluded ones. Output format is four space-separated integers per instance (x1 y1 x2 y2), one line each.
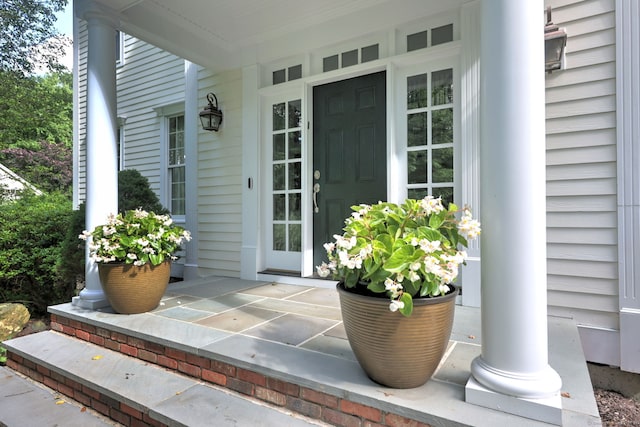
73 5 118 309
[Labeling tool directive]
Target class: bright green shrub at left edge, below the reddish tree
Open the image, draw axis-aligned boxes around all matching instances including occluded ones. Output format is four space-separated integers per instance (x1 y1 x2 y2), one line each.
0 193 74 315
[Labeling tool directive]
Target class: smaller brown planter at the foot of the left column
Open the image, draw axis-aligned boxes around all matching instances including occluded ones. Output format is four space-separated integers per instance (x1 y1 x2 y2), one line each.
98 261 171 314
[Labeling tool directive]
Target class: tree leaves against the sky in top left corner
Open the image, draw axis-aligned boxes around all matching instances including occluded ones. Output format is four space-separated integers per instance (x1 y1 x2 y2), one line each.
0 0 69 75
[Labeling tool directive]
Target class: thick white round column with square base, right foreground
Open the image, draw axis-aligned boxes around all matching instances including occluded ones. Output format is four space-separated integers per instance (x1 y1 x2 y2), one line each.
466 0 562 424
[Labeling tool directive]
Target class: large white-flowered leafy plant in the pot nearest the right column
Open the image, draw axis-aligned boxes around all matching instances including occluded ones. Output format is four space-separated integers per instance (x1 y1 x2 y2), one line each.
316 196 480 316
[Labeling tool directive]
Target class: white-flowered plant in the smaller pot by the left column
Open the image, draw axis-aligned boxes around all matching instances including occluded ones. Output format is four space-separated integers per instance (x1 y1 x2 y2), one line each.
79 209 191 265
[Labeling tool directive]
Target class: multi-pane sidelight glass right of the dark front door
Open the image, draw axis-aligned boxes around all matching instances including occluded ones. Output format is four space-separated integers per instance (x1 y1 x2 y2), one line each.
406 68 454 203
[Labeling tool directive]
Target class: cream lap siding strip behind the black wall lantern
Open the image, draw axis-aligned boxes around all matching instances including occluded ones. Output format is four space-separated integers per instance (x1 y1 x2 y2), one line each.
198 70 242 277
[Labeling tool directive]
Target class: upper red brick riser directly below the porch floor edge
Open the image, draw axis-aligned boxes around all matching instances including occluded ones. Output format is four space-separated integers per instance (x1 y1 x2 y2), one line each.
40 314 429 427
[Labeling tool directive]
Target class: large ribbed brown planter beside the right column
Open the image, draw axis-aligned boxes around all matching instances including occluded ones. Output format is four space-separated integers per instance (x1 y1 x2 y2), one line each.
337 283 459 388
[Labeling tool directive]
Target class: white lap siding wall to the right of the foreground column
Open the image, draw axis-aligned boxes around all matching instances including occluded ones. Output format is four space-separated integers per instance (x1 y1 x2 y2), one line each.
546 0 619 332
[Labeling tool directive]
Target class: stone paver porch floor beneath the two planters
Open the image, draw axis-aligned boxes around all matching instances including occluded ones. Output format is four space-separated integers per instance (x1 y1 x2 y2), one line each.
49 277 600 426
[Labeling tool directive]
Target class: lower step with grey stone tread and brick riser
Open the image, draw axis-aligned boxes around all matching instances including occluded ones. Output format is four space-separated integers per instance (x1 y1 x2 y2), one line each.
3 331 326 427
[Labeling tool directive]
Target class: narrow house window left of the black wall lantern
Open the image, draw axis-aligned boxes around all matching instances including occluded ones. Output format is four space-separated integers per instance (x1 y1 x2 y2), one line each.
168 115 186 215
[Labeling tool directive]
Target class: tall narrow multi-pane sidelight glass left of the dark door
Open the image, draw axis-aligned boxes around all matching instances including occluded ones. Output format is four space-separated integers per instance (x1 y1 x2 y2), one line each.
271 99 302 255
